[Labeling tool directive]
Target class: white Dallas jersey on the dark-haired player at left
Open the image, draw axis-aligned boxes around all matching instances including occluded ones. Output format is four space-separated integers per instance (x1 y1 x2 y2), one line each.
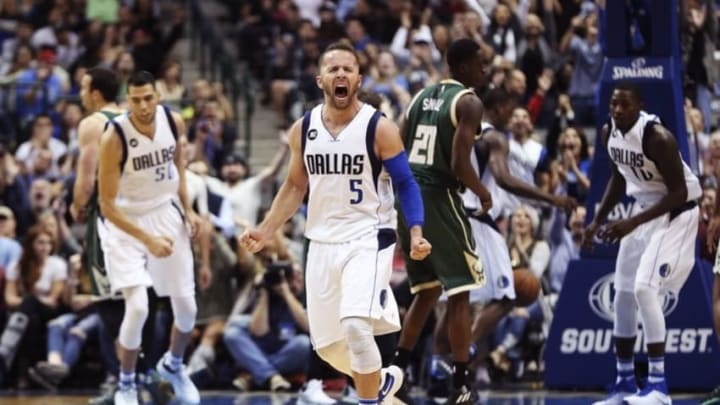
113 106 179 215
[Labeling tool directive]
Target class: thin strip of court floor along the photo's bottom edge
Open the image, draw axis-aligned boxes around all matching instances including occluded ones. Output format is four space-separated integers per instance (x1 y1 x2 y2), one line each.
0 391 703 405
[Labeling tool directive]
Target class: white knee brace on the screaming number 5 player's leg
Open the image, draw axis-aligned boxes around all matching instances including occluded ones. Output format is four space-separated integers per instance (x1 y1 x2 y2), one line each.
340 317 382 374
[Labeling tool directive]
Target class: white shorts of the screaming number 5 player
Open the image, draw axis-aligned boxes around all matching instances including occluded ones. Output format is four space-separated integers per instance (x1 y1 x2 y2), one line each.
305 229 400 350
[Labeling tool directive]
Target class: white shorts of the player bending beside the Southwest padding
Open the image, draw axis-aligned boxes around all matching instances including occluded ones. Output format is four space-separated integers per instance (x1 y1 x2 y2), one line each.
615 206 699 293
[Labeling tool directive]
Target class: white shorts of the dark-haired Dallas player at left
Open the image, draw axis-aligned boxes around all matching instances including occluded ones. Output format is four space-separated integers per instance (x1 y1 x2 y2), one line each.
98 202 195 297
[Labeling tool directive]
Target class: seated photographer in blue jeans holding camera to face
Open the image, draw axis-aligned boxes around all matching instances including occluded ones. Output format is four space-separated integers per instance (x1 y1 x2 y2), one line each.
224 253 311 391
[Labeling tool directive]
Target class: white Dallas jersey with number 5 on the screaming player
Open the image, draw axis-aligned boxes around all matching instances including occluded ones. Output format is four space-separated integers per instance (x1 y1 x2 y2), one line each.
302 104 397 243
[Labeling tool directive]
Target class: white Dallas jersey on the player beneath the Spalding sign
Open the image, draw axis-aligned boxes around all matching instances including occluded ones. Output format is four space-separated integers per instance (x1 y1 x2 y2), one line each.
607 111 702 204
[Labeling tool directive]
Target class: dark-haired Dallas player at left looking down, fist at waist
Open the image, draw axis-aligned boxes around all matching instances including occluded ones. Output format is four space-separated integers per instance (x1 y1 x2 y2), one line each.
98 71 200 405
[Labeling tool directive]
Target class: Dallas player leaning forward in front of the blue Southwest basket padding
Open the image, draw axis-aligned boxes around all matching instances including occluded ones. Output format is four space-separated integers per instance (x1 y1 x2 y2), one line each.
584 83 702 405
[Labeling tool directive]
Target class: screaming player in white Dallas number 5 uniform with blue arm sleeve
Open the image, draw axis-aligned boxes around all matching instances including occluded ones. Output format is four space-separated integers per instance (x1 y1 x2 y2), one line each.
241 42 430 404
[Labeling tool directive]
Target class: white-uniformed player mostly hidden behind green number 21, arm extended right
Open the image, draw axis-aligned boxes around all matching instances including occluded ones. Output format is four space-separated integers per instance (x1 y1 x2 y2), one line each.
428 87 577 402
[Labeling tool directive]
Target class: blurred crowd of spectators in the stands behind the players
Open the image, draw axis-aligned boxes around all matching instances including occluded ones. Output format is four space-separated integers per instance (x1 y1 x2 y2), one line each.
0 0 720 400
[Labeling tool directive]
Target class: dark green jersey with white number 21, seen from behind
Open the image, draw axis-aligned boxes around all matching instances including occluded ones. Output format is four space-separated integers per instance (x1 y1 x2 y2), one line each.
403 80 473 188
